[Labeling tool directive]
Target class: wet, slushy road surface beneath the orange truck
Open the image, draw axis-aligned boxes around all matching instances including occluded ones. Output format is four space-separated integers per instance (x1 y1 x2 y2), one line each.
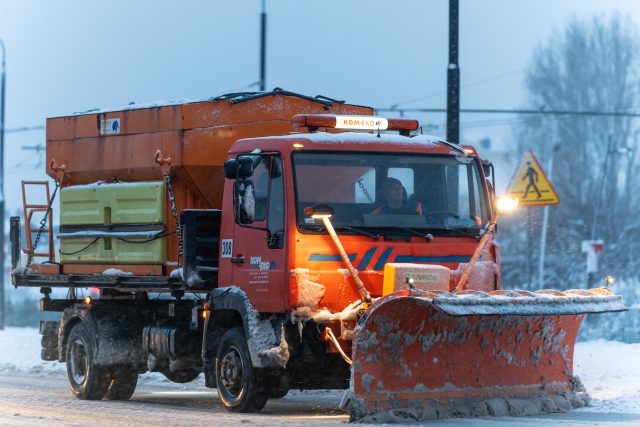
0 373 640 427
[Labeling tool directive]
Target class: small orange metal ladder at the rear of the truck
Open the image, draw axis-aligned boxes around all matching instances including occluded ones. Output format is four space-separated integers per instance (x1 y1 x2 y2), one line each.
22 181 55 262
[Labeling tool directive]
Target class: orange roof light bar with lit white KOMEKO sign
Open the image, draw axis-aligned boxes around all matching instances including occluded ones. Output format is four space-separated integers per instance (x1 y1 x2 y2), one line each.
291 114 419 132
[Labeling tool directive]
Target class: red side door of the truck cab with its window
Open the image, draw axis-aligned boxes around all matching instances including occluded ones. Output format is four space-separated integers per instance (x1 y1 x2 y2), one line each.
231 154 288 313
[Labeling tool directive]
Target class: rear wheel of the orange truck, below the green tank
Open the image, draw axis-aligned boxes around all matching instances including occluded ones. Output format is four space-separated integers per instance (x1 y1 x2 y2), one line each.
66 323 109 400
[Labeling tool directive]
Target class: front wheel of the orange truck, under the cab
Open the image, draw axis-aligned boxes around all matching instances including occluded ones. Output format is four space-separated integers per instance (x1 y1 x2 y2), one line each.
216 328 269 412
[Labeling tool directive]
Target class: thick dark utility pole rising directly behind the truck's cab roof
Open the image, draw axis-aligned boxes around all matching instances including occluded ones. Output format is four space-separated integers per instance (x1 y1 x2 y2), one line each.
447 0 460 144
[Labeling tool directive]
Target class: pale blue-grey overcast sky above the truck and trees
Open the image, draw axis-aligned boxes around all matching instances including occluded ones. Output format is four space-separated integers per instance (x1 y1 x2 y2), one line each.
0 0 640 211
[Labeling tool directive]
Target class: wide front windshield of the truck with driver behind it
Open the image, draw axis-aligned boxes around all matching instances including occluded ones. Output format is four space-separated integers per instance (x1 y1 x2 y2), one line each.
293 151 488 232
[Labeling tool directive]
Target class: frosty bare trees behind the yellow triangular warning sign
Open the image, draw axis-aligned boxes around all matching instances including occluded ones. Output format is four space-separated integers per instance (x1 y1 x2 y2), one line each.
502 15 640 289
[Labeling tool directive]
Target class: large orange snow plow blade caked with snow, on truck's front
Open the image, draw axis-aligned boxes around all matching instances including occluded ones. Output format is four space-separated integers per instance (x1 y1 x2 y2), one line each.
345 289 626 422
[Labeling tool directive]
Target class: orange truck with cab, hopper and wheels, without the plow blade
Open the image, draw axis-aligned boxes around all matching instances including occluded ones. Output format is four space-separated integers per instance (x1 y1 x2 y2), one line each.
11 90 500 411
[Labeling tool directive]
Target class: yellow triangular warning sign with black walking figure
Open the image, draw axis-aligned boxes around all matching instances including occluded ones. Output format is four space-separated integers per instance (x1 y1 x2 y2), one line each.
507 151 560 206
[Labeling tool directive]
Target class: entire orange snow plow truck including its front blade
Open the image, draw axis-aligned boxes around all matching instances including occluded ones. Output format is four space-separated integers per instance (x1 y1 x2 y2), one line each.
10 89 625 421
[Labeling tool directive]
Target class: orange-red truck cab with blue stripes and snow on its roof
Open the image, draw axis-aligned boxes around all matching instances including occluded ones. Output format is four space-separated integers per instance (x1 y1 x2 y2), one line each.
218 120 499 316
